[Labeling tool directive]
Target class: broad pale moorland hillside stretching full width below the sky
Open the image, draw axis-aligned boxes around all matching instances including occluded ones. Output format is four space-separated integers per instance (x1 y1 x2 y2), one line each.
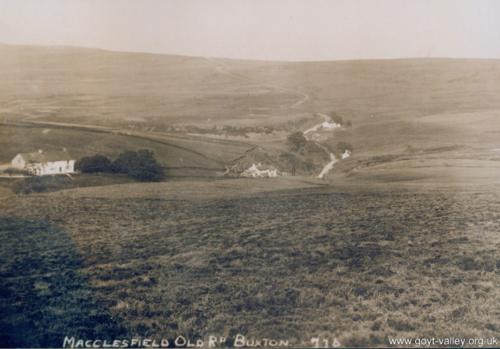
0 45 500 126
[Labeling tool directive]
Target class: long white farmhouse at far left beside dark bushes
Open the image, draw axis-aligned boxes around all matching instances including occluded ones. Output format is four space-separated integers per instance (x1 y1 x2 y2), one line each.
11 150 75 176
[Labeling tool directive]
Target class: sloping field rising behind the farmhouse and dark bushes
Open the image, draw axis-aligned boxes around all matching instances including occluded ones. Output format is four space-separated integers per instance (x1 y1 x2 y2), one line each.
0 125 254 170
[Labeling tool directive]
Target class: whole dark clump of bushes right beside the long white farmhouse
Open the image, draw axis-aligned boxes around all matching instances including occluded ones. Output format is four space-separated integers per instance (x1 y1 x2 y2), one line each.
75 149 164 182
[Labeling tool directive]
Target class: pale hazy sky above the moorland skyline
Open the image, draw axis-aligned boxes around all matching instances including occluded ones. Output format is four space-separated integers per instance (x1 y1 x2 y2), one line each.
0 0 500 60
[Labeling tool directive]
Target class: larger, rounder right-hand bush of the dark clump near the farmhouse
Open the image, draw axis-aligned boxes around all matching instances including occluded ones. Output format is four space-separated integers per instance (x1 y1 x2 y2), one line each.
112 149 164 182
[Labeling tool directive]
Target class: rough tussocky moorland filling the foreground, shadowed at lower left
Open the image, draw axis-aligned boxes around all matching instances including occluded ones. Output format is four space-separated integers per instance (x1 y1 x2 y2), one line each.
0 180 500 346
